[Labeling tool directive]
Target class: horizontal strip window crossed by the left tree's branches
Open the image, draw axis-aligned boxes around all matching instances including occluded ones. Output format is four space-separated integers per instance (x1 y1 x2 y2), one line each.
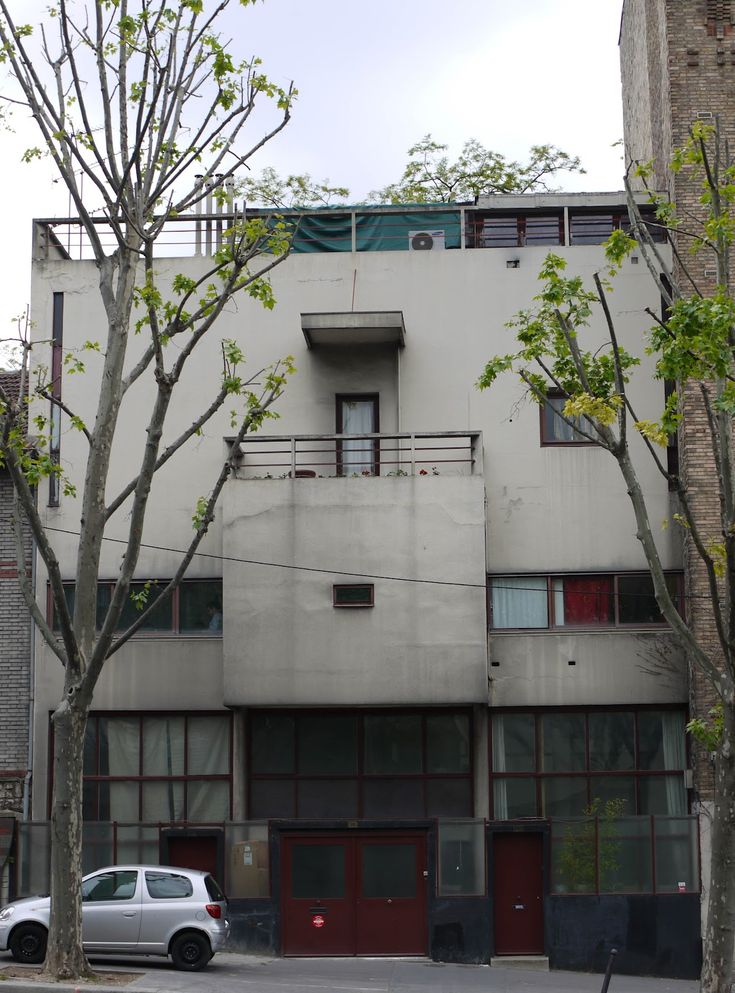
48 579 222 637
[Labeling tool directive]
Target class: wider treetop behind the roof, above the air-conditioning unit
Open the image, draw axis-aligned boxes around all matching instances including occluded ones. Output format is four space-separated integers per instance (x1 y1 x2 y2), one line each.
370 134 584 204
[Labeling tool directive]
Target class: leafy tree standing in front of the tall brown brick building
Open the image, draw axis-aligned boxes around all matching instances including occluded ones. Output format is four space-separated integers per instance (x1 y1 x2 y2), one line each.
479 123 735 993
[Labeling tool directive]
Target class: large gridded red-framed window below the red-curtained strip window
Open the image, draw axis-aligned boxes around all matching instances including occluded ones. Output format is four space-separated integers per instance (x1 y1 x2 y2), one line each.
491 709 687 820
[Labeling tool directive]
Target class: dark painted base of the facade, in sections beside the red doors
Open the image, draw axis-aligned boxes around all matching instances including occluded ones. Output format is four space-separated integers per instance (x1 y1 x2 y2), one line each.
230 893 702 979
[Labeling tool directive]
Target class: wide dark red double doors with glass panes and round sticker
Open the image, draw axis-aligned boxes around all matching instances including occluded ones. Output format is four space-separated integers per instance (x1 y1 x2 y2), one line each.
281 832 428 955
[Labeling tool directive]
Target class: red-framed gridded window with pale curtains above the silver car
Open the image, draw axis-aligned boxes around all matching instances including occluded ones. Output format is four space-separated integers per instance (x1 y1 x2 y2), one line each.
71 711 232 824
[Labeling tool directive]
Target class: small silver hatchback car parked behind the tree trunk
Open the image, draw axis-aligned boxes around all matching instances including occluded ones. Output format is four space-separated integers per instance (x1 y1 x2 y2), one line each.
0 865 230 971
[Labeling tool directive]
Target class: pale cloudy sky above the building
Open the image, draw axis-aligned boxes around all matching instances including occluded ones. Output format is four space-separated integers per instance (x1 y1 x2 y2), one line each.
0 0 623 360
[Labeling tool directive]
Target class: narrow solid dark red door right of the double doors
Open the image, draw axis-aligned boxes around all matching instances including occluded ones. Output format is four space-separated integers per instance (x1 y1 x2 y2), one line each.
493 832 544 955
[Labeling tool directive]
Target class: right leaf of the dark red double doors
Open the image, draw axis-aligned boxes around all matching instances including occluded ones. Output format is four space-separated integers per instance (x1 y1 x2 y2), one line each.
356 835 427 955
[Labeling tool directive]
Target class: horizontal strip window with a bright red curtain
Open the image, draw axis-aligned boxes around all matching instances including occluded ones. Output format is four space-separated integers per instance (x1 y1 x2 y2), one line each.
489 572 684 631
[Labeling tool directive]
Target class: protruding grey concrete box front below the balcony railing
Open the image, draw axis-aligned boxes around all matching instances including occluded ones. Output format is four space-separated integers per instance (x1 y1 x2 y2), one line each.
222 475 487 706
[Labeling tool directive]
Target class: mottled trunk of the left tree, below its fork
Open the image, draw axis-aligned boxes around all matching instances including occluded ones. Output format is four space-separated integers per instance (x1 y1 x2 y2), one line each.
45 697 92 979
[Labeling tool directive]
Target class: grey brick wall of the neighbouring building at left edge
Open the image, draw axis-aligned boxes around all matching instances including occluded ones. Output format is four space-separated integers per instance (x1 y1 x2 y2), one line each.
0 472 31 812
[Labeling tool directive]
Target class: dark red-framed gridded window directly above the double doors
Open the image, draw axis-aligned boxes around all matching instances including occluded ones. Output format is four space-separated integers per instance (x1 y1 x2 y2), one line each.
248 710 473 819
